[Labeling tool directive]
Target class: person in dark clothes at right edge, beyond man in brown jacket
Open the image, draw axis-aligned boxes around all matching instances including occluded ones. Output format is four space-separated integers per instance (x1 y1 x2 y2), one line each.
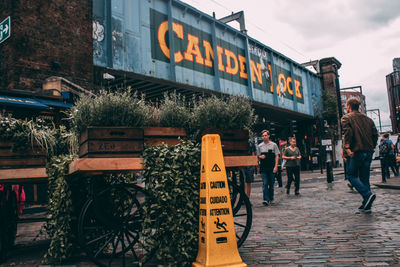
379 133 399 183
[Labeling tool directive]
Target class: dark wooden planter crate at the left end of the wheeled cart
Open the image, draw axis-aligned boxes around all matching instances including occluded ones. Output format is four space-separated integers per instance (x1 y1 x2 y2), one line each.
79 126 143 158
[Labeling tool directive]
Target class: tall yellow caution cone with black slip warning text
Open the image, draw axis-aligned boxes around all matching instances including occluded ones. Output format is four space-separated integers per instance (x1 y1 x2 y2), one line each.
192 134 247 267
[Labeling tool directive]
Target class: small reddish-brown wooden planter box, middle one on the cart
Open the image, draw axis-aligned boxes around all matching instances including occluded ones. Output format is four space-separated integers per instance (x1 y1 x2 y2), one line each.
143 127 186 146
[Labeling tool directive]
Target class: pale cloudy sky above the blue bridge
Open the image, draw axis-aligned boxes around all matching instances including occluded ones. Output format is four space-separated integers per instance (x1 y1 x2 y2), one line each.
182 0 400 130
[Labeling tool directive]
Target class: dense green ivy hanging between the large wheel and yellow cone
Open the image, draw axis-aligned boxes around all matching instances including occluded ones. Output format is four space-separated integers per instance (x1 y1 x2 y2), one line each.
143 141 200 266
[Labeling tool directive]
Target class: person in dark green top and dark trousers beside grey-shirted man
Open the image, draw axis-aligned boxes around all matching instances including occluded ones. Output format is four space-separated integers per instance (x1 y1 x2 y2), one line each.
282 137 301 196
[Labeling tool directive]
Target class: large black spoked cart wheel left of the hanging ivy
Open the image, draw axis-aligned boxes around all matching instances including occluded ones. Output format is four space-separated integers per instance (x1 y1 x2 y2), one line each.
78 184 154 266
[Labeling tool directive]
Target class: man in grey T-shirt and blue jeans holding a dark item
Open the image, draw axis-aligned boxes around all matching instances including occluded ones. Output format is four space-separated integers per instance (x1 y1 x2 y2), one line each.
257 130 280 206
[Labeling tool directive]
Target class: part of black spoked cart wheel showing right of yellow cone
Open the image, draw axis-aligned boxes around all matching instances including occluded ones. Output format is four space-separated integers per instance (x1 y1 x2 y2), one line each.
229 182 253 247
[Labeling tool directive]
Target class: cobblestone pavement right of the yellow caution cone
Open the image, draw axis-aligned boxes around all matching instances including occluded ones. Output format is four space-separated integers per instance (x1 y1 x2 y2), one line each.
239 166 400 266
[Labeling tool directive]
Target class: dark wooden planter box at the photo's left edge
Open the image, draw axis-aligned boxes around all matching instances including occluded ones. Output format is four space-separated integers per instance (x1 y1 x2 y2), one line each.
0 141 47 169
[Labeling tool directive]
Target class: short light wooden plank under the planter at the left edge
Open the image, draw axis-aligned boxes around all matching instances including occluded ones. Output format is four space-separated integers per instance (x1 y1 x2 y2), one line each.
0 168 47 183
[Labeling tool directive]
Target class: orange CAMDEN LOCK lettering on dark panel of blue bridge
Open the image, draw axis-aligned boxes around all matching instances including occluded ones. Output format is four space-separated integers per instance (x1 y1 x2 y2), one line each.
150 9 304 103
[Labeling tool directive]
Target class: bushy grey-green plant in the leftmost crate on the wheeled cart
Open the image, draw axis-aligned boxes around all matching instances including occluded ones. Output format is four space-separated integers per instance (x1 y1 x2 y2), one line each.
68 89 152 134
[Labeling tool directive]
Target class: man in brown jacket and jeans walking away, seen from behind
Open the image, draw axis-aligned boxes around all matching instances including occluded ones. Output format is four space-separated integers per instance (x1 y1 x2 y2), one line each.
342 97 378 213
